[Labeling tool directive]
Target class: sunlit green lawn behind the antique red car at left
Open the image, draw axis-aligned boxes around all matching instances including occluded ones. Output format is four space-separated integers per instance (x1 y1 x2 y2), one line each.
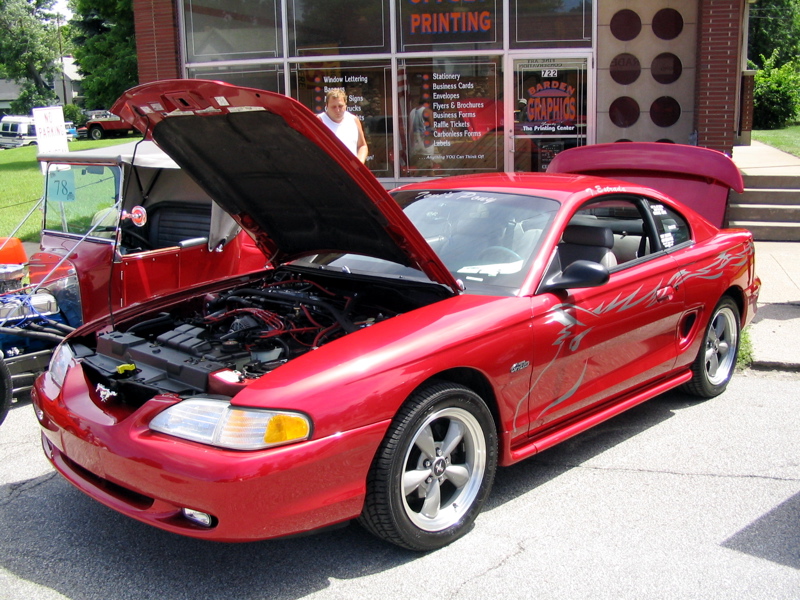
0 137 138 242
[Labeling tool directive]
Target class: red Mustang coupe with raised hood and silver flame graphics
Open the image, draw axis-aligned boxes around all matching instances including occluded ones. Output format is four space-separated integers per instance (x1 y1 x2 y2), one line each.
34 80 760 550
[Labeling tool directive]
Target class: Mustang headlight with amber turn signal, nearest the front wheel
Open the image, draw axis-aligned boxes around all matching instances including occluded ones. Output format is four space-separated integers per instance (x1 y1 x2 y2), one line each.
150 398 311 450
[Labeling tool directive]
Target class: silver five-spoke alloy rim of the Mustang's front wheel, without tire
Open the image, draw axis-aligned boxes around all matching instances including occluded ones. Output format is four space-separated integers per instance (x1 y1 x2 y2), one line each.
402 407 487 531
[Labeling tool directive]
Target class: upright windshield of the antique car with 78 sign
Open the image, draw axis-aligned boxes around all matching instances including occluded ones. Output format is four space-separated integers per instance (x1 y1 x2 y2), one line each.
45 164 120 238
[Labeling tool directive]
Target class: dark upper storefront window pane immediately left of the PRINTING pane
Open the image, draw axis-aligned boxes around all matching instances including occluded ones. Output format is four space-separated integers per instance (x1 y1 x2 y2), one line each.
287 0 390 56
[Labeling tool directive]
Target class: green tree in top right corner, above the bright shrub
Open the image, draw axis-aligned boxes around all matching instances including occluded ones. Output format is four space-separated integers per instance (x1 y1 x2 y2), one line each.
747 0 800 68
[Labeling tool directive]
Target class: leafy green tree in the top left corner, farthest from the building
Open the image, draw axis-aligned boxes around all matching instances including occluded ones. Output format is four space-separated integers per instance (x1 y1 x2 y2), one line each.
0 0 58 114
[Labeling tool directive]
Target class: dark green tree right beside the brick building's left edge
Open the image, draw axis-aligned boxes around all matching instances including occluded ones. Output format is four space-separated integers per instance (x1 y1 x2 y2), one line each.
70 0 138 110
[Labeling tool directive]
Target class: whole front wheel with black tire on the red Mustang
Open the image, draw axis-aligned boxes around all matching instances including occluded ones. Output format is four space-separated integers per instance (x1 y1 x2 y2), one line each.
359 383 497 551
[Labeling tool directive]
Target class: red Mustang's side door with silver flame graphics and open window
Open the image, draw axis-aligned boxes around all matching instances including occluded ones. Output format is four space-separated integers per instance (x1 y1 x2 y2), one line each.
530 196 684 429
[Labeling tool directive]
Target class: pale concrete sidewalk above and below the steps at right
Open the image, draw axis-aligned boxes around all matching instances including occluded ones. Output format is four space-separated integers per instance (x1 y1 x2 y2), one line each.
733 141 800 371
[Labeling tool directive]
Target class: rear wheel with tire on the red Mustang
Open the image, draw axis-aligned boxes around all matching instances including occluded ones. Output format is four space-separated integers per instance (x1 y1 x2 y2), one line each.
684 296 741 398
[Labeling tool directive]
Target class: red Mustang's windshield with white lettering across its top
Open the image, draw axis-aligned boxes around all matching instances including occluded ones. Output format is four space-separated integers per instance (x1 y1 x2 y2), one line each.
301 190 559 295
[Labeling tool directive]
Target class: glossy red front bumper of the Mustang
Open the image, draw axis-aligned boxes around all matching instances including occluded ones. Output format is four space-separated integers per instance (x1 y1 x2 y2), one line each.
32 369 389 542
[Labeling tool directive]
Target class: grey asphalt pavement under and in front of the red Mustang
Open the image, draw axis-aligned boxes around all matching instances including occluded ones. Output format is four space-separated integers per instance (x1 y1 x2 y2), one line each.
0 370 800 600
